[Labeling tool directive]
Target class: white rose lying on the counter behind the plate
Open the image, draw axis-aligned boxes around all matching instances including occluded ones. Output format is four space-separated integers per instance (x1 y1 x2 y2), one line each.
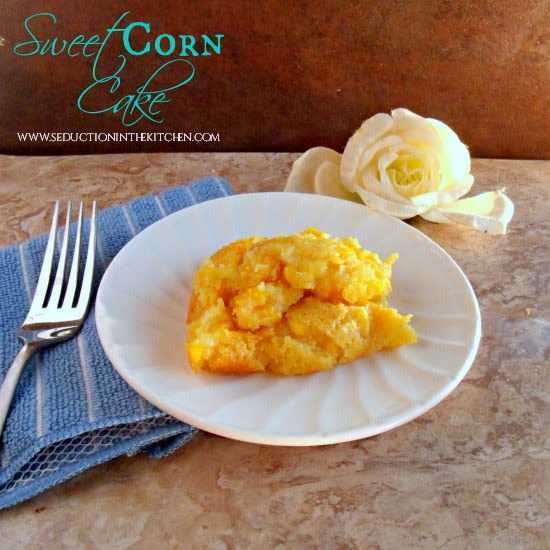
285 109 514 234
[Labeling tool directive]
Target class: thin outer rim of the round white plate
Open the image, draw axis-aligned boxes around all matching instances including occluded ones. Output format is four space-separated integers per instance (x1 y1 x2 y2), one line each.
94 191 482 447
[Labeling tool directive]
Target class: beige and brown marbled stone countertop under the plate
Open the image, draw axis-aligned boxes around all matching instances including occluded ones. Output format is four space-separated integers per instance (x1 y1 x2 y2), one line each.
0 153 550 550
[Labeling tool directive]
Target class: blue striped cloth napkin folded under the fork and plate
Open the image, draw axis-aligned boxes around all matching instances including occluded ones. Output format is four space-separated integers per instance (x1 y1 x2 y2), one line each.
0 177 232 509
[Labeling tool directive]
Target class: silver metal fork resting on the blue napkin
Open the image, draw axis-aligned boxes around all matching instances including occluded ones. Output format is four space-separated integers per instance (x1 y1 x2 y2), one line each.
0 201 96 434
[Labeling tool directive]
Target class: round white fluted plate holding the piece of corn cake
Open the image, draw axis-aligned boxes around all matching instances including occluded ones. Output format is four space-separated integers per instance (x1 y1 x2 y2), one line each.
96 193 481 445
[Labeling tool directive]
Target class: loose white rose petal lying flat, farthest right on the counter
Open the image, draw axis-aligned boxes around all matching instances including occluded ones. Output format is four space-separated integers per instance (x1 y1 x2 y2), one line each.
421 190 514 235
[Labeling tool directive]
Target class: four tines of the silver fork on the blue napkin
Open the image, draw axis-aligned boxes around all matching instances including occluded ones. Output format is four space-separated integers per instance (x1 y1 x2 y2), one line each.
27 201 96 322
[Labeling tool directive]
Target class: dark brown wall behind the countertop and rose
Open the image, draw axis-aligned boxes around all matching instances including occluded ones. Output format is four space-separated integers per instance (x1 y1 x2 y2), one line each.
0 0 550 158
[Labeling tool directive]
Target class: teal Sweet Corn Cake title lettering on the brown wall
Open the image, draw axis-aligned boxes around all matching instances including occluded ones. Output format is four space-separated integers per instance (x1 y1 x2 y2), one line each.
13 12 224 126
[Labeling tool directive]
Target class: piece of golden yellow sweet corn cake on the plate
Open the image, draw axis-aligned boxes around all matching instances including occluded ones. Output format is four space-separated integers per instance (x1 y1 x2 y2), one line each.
187 228 416 375
